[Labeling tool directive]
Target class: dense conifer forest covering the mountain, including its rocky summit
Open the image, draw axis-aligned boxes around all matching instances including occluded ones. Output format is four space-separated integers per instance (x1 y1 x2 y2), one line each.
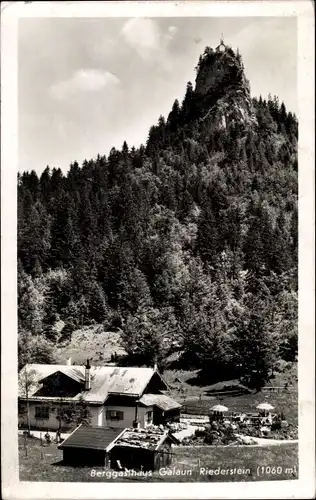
18 47 298 389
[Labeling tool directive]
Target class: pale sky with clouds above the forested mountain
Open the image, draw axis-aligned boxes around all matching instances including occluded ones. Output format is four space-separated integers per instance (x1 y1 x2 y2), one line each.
18 17 298 173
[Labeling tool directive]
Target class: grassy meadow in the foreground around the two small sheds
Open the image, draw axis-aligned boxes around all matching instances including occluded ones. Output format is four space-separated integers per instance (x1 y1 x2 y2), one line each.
19 436 298 482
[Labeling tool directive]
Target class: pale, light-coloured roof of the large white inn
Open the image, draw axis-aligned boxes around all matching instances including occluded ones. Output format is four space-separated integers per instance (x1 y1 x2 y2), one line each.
19 364 167 404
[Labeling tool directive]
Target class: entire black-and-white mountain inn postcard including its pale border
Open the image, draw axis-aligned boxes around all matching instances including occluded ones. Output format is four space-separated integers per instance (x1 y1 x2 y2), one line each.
2 1 314 498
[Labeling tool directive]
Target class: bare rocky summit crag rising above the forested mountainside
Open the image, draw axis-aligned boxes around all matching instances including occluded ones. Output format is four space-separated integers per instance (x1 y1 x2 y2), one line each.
195 47 257 129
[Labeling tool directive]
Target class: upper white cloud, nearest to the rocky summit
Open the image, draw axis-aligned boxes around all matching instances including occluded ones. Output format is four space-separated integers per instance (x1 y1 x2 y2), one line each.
121 18 177 68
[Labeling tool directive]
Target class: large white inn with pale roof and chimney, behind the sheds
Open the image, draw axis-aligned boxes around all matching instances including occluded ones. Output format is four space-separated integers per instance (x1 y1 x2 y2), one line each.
19 362 181 431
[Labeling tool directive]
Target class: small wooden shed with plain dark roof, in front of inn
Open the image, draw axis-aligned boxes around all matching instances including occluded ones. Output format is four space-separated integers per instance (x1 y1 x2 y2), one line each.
58 425 124 466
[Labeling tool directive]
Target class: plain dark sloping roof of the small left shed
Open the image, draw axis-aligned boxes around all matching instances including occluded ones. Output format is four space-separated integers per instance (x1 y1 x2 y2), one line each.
58 425 122 450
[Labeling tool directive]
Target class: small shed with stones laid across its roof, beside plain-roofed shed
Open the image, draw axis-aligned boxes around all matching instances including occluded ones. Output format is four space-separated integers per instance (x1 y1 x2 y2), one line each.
107 426 178 470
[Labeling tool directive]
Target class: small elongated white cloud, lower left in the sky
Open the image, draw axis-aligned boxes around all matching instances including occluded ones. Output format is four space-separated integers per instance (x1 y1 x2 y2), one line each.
49 69 120 100
